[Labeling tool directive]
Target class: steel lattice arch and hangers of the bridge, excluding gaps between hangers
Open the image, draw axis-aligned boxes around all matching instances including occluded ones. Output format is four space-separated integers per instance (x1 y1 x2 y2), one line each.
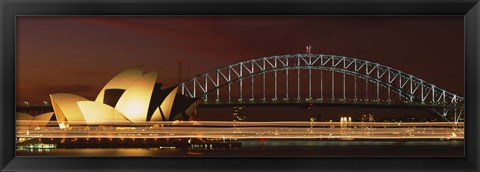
180 54 464 122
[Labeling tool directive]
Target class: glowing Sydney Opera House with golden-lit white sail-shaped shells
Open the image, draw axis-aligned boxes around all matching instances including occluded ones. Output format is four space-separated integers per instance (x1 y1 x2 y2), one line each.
16 67 201 128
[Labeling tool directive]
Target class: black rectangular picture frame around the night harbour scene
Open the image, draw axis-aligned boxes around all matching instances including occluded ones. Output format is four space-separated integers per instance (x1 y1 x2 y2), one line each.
0 0 480 171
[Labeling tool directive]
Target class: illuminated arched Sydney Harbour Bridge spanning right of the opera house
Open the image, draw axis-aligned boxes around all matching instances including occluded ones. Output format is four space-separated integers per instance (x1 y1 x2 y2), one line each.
180 53 464 124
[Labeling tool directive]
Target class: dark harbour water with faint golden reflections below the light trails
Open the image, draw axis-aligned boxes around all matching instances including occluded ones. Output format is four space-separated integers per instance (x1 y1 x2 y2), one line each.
16 139 464 157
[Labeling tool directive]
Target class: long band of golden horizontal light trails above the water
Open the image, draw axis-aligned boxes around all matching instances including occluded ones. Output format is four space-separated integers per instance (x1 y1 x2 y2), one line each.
17 121 464 140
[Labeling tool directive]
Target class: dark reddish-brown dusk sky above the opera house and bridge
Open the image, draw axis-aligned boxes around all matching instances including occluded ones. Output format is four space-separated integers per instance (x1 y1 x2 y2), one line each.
17 16 464 106
